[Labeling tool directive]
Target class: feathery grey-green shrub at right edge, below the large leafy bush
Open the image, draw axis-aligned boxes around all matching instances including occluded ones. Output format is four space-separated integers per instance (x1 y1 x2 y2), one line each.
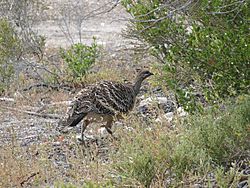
172 97 250 175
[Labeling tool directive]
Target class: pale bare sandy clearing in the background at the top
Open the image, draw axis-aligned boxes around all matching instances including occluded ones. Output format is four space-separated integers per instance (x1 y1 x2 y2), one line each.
35 0 129 50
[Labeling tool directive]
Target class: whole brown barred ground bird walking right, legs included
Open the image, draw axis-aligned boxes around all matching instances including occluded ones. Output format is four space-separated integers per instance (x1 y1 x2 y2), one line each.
61 70 153 141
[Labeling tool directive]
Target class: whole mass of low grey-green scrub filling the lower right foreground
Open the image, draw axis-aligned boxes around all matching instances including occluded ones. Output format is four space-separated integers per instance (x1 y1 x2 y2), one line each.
113 96 250 187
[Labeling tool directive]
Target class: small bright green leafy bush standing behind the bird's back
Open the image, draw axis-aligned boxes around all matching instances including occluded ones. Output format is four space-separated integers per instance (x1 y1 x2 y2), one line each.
61 40 98 79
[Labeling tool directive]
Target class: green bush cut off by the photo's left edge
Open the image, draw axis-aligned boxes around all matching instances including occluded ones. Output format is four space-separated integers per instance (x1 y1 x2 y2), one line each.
0 19 21 93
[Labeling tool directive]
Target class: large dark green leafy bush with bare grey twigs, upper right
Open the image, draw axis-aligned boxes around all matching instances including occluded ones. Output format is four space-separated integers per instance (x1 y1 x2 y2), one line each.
123 0 250 110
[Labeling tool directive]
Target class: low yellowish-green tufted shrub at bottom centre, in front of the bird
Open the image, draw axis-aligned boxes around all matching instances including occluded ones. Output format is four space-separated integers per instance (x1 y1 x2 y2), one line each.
113 122 171 187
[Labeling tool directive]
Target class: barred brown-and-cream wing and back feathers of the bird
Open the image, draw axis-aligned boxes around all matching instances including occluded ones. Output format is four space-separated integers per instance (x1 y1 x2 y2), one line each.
68 81 136 116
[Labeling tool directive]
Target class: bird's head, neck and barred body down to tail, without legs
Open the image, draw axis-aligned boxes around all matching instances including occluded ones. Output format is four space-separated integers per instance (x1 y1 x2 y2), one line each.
63 71 152 126
